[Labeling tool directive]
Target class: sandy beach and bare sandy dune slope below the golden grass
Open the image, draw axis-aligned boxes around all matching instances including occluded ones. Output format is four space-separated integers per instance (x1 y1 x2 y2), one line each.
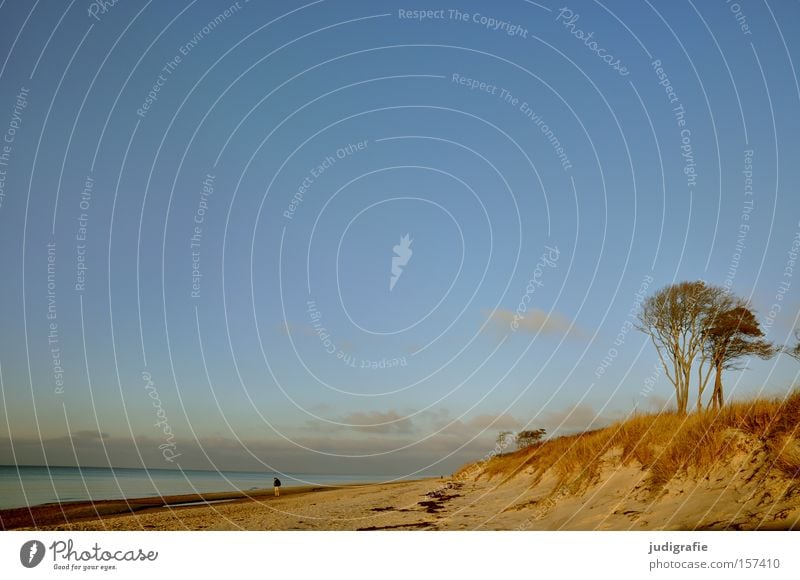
6 450 800 531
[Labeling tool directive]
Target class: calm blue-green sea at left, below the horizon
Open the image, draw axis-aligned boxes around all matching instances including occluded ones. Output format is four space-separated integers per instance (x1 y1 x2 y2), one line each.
0 465 404 509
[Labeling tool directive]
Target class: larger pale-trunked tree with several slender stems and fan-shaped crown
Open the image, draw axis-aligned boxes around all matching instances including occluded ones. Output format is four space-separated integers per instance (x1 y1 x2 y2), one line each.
637 280 731 414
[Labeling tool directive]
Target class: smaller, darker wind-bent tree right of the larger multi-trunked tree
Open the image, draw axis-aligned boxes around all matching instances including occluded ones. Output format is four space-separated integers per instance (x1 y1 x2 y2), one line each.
705 306 777 409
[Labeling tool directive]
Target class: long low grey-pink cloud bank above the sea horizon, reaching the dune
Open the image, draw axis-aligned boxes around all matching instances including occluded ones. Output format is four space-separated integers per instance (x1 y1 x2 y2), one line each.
0 406 615 476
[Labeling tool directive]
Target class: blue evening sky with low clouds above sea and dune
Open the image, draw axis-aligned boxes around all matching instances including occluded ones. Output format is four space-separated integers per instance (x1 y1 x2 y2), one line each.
0 0 800 476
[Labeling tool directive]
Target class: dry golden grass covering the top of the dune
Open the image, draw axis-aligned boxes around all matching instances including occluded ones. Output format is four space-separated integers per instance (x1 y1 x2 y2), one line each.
468 390 800 492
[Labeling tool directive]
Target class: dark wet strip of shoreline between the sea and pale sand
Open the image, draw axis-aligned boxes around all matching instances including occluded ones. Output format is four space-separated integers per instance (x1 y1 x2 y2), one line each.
0 478 438 531
